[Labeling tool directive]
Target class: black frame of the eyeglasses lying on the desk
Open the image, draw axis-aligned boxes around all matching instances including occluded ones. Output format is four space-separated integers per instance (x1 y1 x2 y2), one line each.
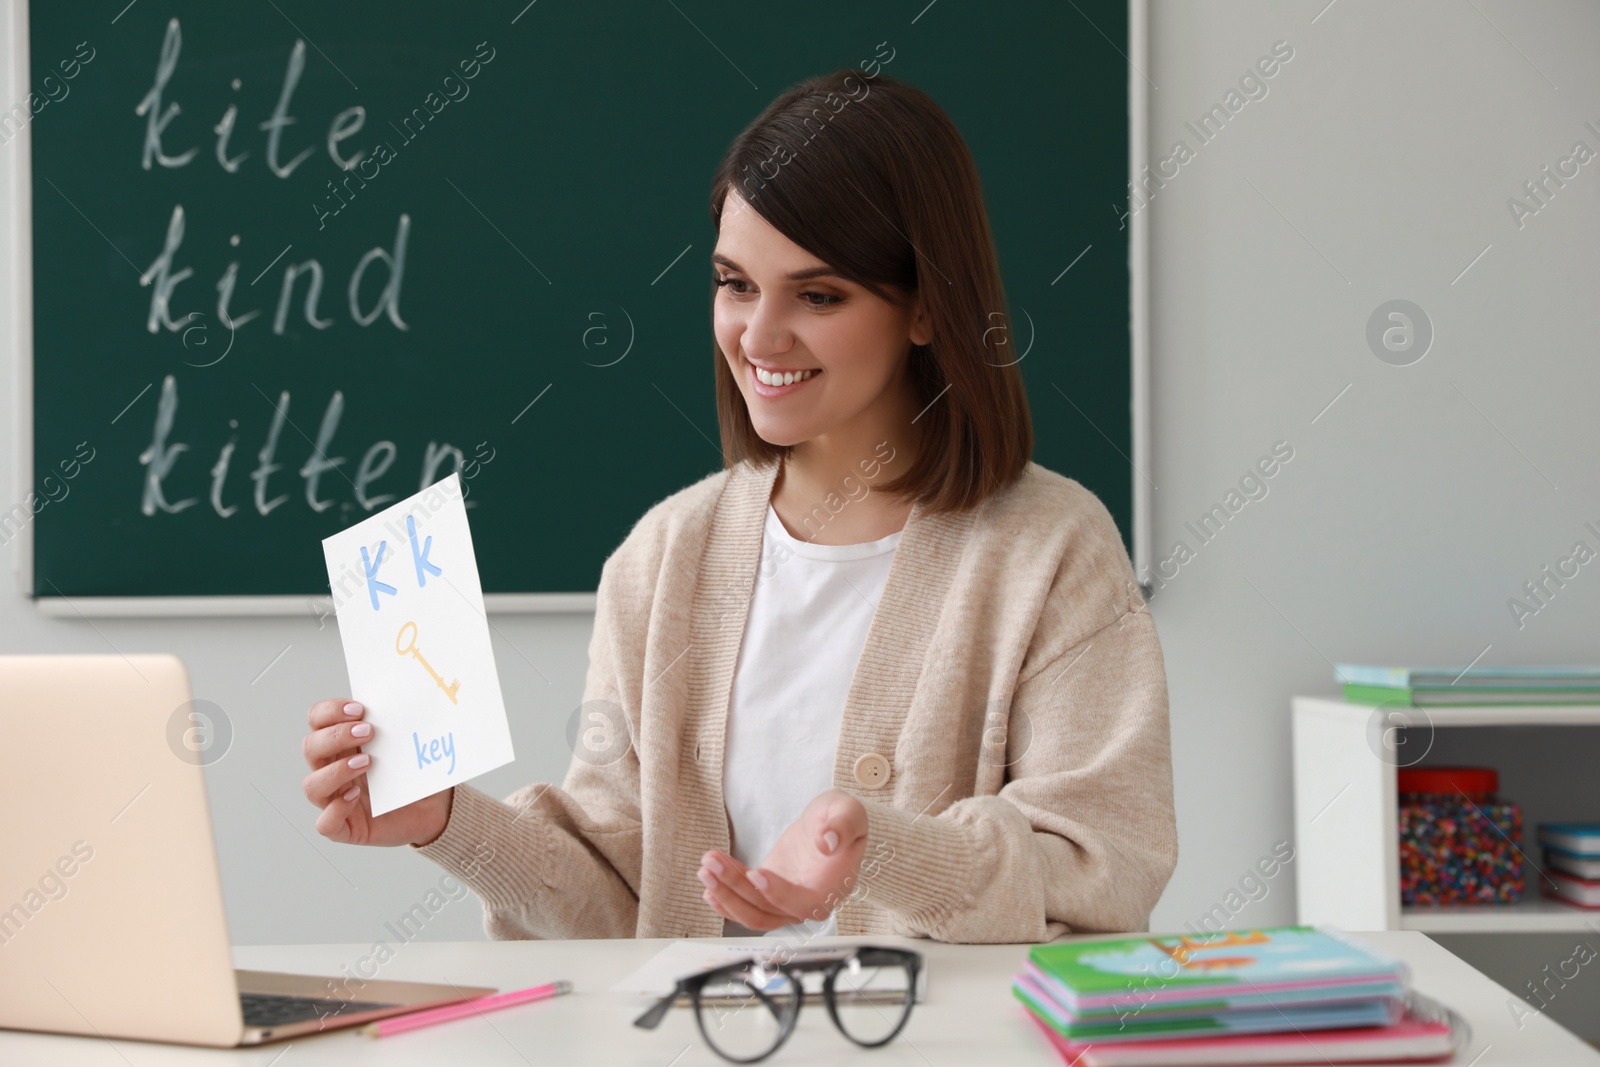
634 945 922 1064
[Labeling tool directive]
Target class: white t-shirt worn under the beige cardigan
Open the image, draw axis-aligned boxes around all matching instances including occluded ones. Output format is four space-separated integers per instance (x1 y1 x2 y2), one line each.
722 504 901 937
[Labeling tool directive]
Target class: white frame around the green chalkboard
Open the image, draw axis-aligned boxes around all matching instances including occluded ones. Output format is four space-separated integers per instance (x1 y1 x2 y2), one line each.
0 0 1152 619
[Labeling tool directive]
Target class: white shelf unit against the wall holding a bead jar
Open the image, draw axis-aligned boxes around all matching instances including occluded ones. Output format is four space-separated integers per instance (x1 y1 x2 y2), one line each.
1293 696 1600 934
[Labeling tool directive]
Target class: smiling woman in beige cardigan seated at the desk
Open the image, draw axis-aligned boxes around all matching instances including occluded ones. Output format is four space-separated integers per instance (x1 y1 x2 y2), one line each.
304 70 1178 942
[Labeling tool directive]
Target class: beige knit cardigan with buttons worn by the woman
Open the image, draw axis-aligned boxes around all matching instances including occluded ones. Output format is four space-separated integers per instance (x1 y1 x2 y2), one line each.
418 462 1178 942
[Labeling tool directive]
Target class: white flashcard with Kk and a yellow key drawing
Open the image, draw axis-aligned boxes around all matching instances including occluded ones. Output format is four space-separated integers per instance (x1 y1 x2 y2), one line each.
322 474 512 816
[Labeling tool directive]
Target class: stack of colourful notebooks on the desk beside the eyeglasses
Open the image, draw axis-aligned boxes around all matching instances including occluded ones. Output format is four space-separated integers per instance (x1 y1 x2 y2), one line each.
1011 926 1469 1067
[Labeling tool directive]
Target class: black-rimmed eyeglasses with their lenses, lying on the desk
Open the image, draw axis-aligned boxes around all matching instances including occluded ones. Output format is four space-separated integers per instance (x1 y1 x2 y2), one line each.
634 945 922 1064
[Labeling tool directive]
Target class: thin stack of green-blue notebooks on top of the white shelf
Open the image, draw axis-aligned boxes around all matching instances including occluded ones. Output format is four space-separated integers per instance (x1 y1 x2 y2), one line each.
1333 664 1600 707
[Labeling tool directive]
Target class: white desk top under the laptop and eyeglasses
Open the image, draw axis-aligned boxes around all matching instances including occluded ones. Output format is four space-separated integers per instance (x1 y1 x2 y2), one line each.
0 931 1600 1067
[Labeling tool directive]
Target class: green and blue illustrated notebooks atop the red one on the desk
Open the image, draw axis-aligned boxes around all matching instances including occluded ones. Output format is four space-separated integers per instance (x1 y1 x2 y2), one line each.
1029 926 1406 1014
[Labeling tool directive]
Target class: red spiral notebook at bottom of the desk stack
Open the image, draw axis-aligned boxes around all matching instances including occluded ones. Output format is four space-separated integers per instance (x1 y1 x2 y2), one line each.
1029 993 1470 1067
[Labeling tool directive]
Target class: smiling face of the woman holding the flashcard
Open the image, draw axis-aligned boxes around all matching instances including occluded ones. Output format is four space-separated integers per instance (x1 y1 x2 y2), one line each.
712 190 928 445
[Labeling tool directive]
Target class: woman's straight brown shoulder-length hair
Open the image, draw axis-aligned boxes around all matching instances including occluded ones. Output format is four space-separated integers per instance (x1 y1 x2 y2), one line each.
710 67 1034 512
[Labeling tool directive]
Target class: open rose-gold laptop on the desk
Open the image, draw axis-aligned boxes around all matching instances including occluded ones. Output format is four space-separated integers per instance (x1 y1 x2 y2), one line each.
0 656 496 1048
